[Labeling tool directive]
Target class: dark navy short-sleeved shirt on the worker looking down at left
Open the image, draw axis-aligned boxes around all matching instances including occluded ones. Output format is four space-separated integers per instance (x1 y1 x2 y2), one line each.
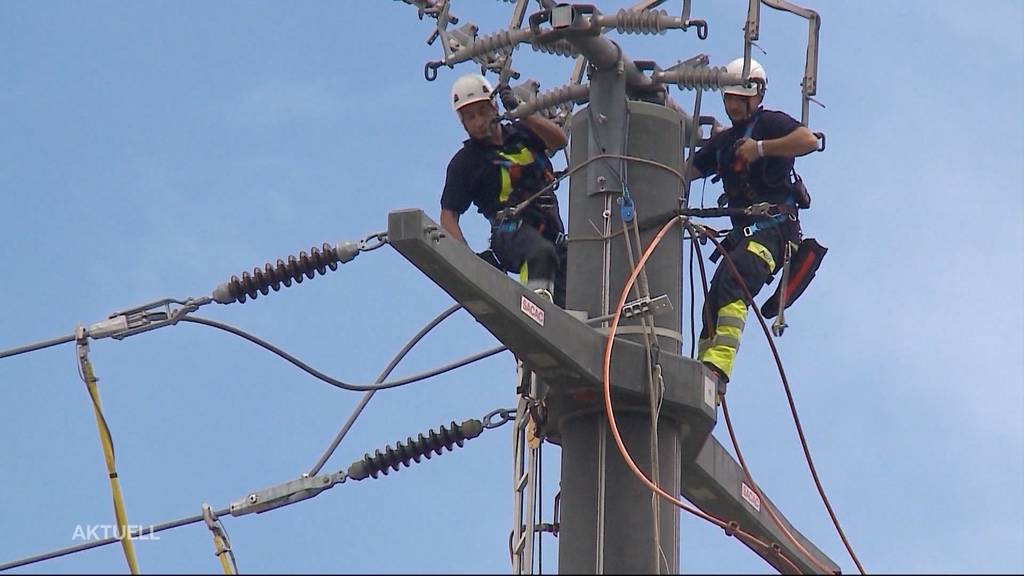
441 122 547 219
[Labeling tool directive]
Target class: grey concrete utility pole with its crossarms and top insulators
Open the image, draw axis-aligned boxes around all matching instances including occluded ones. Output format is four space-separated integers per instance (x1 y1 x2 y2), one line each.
388 0 839 574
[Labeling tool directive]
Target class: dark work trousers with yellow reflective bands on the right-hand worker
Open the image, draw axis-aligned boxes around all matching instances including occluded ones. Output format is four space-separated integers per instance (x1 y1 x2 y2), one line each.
697 227 785 381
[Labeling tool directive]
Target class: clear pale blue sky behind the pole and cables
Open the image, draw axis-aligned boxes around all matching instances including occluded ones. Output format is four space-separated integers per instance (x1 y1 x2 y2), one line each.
0 0 1024 573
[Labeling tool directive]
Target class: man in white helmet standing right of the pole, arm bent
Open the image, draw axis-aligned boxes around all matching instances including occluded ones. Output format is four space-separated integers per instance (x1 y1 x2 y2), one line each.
690 58 818 382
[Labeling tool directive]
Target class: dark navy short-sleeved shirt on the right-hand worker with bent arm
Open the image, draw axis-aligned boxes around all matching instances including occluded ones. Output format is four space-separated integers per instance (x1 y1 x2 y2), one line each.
693 109 803 225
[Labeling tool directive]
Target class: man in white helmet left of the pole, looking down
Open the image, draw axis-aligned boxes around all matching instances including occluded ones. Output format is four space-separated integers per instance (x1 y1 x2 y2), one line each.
440 74 568 305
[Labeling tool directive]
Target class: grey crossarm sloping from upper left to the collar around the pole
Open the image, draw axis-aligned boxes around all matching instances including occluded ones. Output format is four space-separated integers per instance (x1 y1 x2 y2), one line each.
388 209 716 446
